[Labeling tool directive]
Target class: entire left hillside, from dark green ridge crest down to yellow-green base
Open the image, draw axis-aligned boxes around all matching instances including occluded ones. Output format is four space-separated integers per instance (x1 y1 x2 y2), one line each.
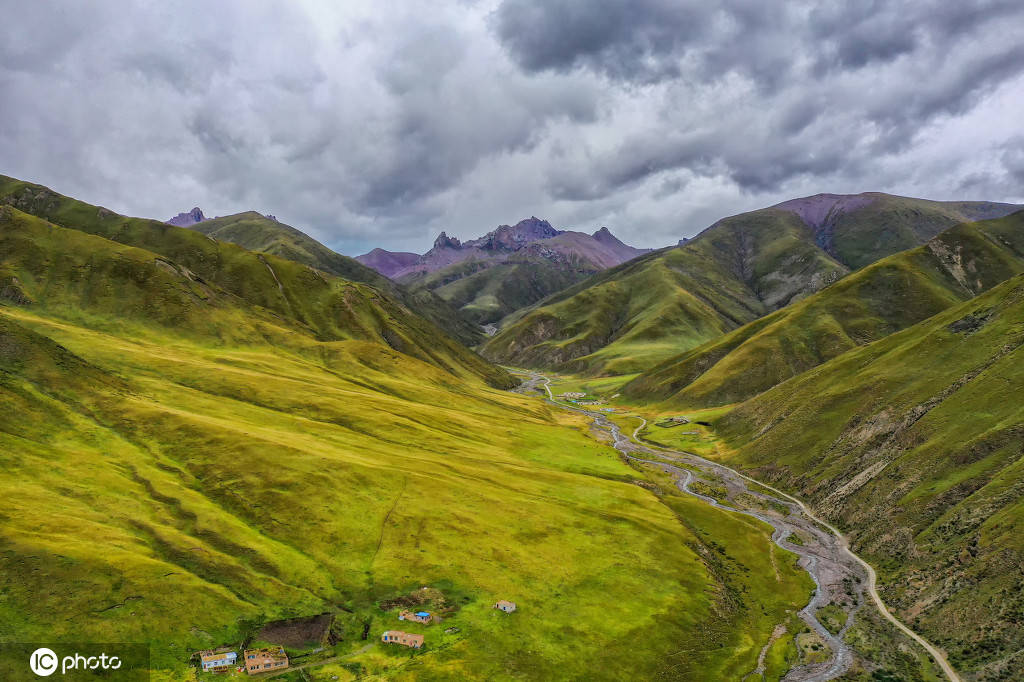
0 187 811 680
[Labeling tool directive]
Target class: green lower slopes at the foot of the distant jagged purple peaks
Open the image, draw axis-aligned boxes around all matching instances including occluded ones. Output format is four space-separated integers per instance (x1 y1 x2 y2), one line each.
402 257 595 325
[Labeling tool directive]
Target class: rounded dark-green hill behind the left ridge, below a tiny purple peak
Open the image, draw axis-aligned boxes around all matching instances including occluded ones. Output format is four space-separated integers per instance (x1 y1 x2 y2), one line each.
191 211 483 345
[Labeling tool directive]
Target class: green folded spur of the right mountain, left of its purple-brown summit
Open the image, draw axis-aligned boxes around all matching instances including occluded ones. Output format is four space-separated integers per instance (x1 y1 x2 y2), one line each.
482 211 846 375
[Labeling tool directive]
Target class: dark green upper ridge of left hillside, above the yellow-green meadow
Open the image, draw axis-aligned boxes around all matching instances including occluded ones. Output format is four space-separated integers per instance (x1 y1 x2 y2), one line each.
0 178 499 386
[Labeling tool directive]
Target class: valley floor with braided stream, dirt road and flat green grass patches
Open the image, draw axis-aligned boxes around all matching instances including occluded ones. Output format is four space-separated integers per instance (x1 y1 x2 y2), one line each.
521 373 961 682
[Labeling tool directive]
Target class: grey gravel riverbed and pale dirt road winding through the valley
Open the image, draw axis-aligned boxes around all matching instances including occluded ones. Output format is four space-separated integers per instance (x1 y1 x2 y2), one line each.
518 373 959 682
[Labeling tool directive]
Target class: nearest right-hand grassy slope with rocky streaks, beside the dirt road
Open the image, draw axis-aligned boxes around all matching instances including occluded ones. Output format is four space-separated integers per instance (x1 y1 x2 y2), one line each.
717 275 1024 680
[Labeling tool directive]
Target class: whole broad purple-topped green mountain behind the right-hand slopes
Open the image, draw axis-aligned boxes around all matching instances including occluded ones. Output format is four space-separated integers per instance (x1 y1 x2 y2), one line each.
483 193 1020 375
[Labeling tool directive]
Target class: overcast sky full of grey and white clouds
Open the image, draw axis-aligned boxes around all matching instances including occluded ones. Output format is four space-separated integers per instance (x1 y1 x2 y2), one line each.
0 0 1024 255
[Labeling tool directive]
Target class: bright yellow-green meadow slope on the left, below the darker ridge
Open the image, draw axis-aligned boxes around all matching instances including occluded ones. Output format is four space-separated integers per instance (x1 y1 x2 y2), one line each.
0 308 806 679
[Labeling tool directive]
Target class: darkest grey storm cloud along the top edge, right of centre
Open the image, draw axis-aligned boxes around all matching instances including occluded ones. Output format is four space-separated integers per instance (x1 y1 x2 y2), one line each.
495 0 793 84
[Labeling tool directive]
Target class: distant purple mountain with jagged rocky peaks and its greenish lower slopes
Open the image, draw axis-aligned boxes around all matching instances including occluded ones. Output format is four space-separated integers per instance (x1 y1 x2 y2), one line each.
356 216 650 325
